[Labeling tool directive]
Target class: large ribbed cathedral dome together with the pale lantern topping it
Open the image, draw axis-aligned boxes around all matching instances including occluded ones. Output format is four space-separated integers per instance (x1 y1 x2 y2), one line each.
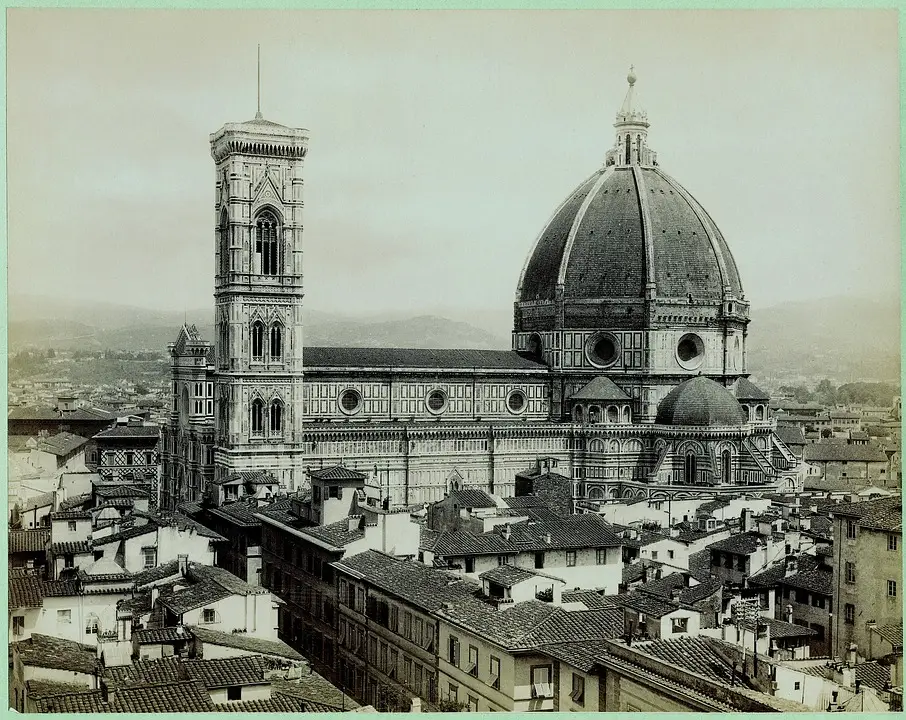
516 70 744 331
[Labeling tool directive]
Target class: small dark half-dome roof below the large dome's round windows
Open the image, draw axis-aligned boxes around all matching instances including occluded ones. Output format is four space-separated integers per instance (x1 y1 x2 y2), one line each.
655 375 746 426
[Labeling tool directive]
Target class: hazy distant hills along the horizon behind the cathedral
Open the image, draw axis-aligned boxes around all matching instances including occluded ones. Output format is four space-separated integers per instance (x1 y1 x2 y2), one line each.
9 296 900 384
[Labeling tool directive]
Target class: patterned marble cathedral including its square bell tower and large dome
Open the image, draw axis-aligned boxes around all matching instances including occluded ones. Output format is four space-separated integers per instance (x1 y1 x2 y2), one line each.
162 72 798 505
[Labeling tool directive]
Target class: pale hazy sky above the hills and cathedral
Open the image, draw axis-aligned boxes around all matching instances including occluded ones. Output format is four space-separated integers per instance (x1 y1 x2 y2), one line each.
7 9 900 324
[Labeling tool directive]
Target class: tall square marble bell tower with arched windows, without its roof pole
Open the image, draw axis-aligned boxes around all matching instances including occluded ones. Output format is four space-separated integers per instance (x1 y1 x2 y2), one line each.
211 111 308 488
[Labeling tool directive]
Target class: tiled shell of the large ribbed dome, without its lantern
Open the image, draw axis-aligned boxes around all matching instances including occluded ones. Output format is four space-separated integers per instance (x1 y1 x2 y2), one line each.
517 164 742 303
